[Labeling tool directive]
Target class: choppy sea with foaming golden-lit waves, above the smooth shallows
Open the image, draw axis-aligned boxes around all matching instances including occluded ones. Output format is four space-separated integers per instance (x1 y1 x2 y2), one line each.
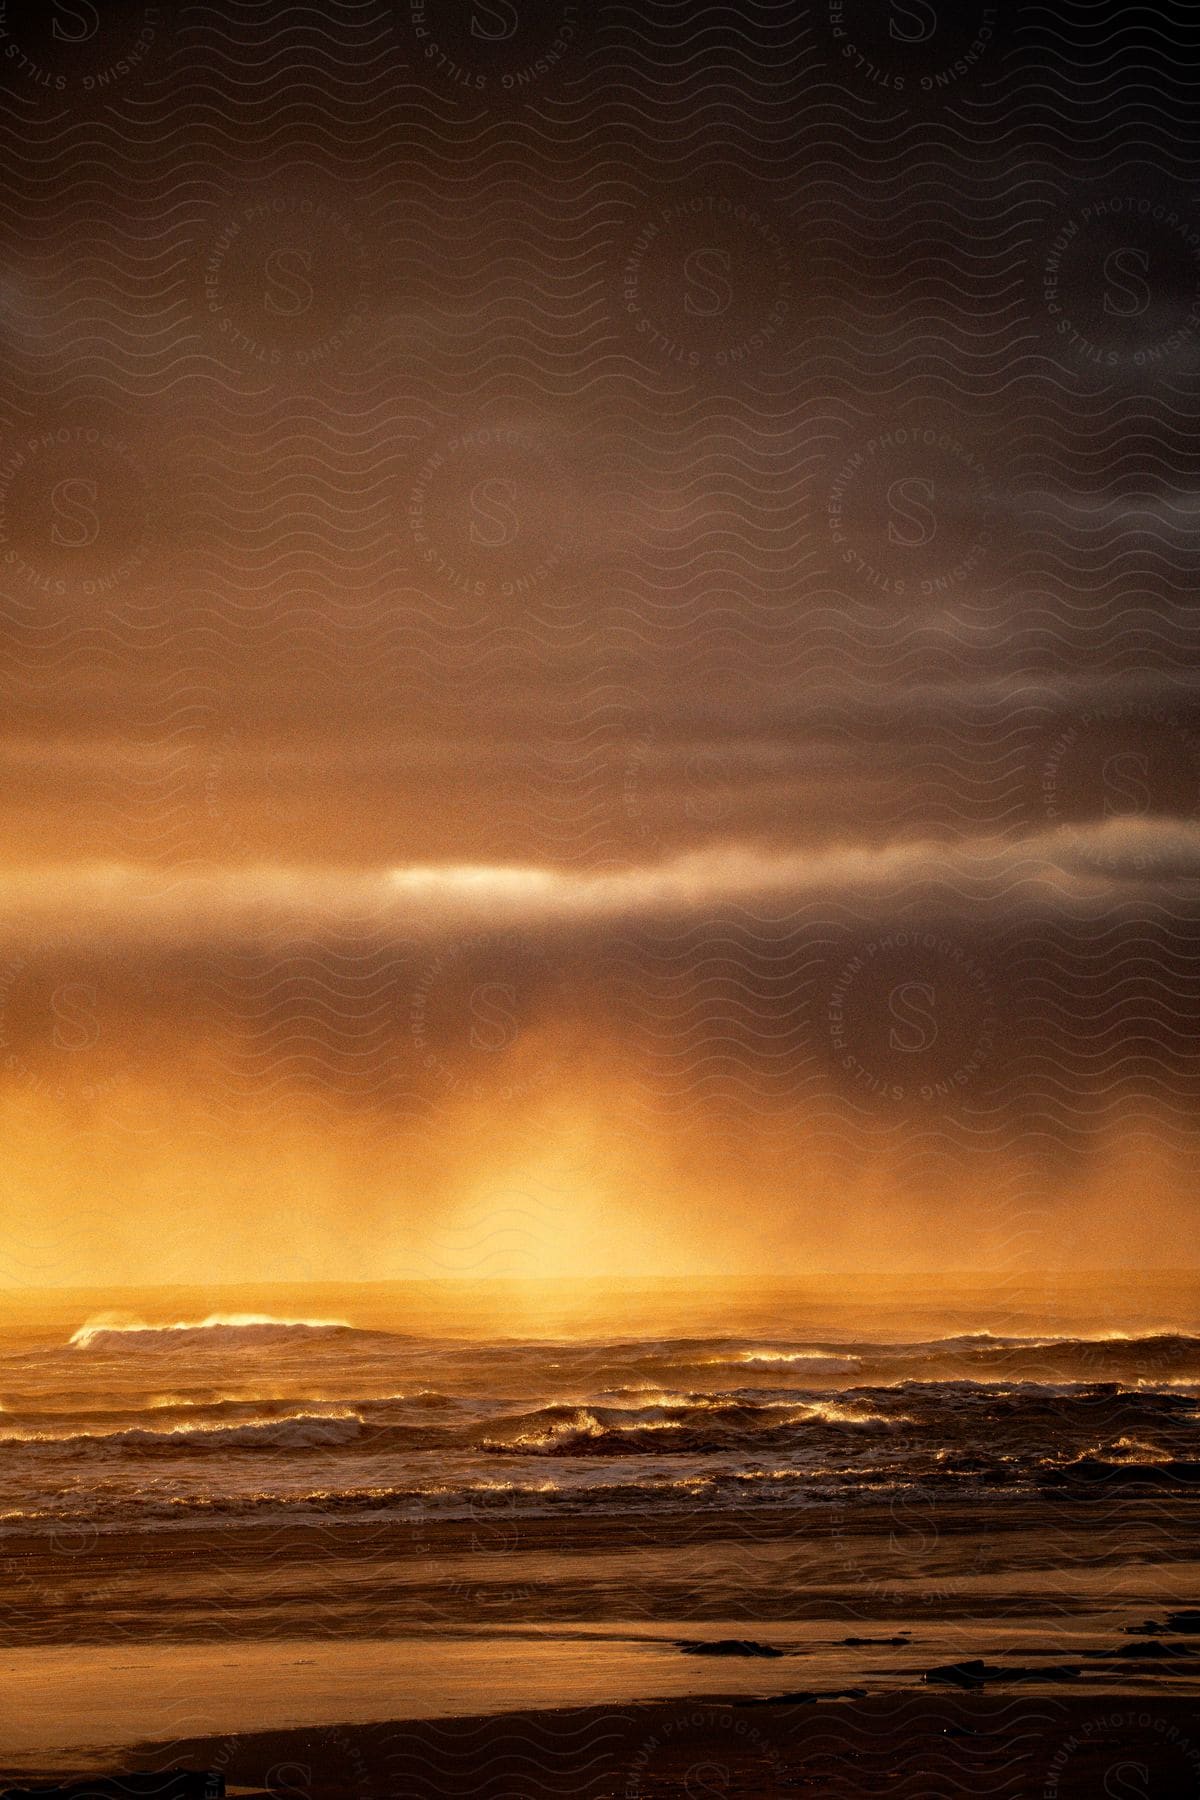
0 1282 1200 1535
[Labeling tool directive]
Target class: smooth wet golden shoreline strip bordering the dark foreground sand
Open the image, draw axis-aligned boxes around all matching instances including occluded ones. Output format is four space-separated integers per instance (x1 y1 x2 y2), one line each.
0 1613 1200 1795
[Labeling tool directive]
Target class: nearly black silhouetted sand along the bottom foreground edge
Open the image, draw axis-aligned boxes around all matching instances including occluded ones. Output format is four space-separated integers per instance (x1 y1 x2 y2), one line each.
9 1692 1200 1800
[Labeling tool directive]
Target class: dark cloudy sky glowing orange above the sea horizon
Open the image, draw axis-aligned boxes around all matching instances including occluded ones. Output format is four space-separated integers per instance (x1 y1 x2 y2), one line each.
0 0 1200 1289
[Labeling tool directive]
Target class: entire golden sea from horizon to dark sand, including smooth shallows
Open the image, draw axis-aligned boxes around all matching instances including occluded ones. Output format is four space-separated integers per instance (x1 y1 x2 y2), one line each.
0 1276 1200 1769
